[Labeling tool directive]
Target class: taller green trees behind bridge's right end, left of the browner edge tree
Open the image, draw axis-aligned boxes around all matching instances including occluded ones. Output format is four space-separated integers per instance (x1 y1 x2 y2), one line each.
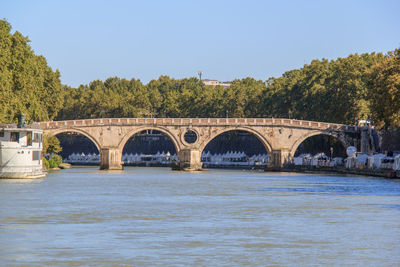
264 53 383 124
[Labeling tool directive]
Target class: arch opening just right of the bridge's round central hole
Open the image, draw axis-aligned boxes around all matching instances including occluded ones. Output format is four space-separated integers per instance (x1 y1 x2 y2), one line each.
201 130 269 169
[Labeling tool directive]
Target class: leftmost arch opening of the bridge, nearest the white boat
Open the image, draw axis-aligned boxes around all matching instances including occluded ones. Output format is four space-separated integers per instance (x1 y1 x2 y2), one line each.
56 132 100 166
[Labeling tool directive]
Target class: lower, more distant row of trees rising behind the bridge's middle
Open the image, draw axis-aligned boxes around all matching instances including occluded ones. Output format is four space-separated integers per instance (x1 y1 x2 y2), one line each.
57 76 266 120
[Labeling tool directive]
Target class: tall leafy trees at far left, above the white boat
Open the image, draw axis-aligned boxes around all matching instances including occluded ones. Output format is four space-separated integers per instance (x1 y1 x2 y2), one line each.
0 20 63 123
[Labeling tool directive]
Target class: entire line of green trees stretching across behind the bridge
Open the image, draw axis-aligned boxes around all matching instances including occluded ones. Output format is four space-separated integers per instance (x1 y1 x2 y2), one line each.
0 20 400 128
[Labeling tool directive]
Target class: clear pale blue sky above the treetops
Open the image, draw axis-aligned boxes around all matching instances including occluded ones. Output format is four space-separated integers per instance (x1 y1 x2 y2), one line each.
0 0 400 87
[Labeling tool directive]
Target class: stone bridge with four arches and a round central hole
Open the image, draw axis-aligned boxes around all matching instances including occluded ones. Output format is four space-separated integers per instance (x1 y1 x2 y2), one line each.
40 118 357 170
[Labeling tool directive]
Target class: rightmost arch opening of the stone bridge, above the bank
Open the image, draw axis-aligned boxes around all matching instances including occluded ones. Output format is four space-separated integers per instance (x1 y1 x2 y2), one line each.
294 134 346 158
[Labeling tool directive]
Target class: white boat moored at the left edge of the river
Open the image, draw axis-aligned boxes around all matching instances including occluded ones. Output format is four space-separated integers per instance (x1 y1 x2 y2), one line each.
0 116 46 179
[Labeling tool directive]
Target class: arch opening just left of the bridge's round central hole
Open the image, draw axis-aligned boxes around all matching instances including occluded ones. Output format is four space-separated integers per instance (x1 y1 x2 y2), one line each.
122 130 178 167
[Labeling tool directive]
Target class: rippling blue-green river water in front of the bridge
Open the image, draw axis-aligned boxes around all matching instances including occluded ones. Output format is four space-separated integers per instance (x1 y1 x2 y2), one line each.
0 168 400 266
